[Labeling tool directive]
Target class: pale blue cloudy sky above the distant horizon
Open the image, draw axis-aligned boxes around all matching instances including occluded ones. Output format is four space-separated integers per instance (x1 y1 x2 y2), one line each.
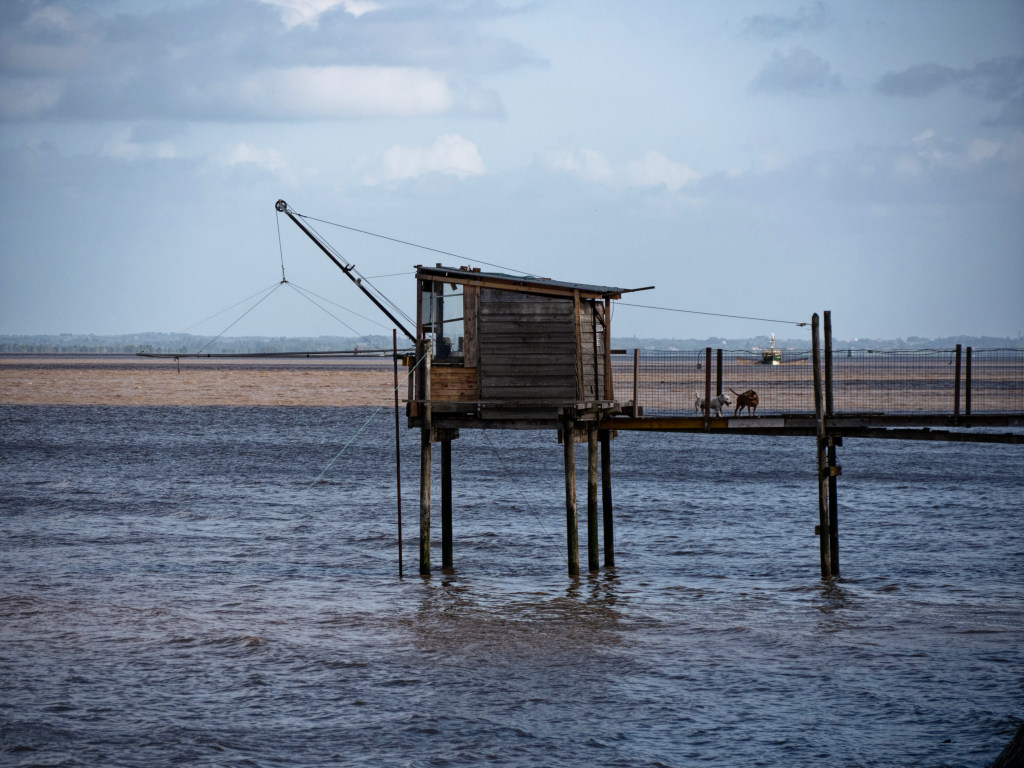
0 0 1024 339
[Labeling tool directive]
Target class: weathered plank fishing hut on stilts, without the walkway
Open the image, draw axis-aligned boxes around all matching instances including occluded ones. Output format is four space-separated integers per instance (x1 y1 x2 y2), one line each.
408 264 645 575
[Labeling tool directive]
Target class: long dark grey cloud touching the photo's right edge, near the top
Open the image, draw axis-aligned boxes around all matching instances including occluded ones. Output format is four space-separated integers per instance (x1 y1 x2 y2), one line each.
874 56 1024 101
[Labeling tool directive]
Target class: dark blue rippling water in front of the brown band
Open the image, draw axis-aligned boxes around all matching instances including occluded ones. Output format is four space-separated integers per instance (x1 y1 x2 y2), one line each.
0 407 1024 767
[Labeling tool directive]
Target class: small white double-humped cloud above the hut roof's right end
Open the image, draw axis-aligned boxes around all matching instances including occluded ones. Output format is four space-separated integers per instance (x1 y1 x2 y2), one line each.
545 150 700 193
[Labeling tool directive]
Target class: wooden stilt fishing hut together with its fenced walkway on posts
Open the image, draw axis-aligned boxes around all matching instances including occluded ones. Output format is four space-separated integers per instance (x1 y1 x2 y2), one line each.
407 264 1024 579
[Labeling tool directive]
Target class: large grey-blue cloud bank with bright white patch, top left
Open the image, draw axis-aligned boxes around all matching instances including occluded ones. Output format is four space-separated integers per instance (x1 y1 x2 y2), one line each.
0 0 520 121
